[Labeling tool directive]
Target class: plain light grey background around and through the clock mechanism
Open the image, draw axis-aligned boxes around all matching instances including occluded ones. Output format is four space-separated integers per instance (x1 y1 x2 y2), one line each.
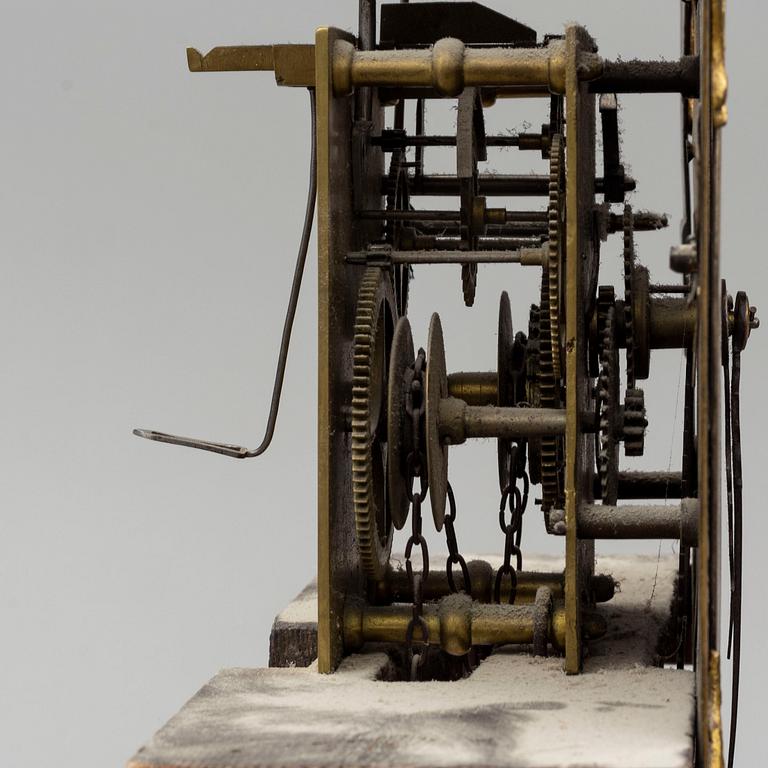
0 0 768 768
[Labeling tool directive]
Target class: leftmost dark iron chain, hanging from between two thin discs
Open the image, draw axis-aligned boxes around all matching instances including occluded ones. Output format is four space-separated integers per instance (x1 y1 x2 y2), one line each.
405 349 429 680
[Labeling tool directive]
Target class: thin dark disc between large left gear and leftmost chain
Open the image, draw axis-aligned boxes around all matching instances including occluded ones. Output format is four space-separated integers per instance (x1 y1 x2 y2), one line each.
387 317 416 530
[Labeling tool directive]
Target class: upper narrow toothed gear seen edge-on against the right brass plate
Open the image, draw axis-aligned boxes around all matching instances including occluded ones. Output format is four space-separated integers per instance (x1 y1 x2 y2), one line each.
546 133 565 385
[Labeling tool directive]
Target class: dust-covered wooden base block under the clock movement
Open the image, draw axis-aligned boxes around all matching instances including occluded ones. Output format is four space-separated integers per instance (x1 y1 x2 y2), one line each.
129 558 694 768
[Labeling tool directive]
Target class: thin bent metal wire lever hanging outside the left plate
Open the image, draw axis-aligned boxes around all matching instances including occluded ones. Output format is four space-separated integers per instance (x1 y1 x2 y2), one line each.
133 88 317 459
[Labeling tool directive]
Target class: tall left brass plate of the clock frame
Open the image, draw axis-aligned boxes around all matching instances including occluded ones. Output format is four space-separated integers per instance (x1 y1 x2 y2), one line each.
314 27 384 672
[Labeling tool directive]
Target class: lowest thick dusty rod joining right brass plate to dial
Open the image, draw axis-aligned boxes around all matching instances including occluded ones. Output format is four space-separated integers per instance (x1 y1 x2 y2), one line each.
578 499 699 546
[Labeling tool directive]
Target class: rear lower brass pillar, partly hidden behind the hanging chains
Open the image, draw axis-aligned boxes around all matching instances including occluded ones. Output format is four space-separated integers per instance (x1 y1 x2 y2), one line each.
374 560 616 605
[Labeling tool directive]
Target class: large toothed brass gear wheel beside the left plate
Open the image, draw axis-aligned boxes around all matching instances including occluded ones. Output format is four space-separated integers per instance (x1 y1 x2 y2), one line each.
352 267 397 581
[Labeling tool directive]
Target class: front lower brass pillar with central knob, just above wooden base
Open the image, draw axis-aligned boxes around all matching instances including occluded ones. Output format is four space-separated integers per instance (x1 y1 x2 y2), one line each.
344 595 606 655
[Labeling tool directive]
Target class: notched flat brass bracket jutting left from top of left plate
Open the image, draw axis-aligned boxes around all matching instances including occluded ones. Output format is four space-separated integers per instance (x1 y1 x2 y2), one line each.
187 44 315 88
